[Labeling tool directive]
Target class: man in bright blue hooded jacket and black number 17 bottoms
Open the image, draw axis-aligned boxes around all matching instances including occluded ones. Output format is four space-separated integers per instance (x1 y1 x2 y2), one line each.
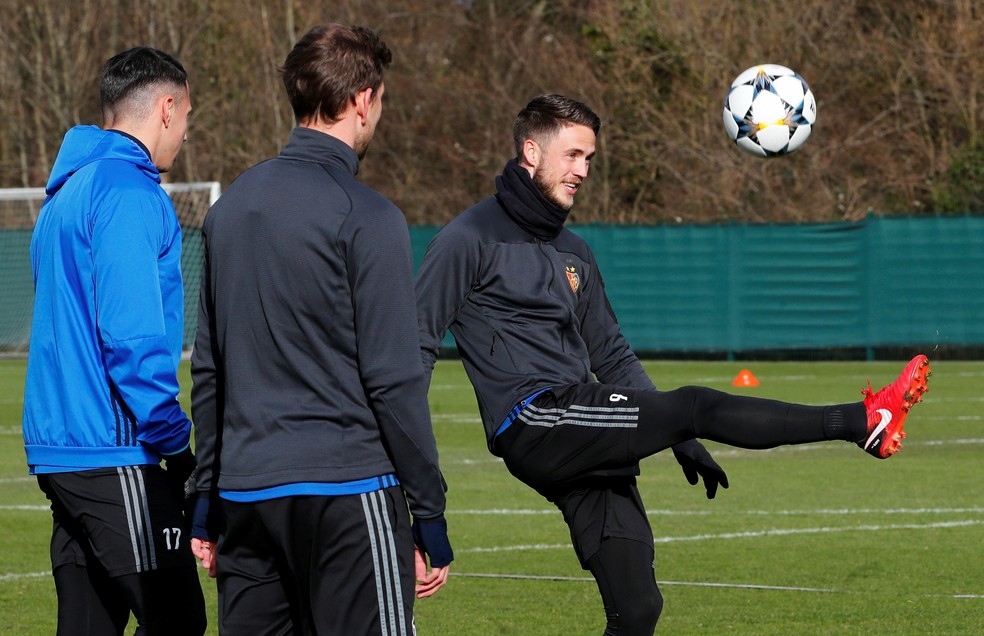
23 47 205 635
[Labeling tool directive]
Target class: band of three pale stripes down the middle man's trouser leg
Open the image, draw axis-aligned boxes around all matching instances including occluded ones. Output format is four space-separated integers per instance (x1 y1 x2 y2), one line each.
360 490 416 636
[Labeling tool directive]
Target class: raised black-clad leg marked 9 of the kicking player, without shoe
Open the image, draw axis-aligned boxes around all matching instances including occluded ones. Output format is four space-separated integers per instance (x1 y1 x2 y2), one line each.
495 383 867 494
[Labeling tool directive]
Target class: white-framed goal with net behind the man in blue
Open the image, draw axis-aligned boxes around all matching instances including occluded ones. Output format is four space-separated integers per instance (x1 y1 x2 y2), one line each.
0 181 221 353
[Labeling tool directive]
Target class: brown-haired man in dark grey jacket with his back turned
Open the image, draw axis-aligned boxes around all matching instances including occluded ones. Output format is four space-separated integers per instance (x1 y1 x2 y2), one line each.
192 25 453 636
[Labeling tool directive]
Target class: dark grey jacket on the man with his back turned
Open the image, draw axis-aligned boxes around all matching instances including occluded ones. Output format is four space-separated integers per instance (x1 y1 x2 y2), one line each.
192 128 445 519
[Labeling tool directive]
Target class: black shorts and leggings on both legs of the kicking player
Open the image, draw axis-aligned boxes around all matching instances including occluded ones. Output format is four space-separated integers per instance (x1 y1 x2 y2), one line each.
495 384 867 636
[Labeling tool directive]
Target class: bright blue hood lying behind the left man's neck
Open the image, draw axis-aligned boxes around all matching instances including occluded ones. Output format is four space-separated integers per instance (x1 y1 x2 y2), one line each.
45 126 161 195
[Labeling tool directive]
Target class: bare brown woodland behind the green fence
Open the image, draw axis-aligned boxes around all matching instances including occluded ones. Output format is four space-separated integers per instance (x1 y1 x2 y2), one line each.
0 0 984 223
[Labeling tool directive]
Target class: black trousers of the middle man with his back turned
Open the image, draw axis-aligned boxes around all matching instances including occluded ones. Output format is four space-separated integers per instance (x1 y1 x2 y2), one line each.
216 487 416 636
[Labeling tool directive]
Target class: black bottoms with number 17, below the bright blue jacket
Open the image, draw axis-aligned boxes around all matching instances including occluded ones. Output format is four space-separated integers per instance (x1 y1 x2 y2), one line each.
38 465 206 636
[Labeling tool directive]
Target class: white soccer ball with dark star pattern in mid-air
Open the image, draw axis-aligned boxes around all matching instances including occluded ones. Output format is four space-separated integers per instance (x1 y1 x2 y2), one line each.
724 64 817 157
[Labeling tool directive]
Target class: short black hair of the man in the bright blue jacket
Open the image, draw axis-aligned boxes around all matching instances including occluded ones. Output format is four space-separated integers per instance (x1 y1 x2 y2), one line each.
99 46 188 115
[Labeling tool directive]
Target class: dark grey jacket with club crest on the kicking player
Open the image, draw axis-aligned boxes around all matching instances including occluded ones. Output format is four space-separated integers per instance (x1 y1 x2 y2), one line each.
417 197 653 453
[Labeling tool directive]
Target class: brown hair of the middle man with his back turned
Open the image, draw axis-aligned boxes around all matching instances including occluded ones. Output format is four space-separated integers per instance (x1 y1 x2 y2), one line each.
280 24 393 123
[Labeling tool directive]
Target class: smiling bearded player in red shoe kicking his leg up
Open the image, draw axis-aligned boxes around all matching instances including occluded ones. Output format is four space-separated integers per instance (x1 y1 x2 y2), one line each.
417 95 929 636
